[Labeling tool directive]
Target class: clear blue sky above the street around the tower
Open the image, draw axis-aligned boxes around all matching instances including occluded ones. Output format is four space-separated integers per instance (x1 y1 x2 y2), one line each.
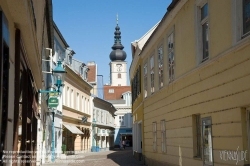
52 0 171 84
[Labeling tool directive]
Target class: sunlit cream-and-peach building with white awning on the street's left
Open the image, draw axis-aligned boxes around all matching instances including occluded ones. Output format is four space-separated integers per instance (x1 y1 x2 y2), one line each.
62 65 92 154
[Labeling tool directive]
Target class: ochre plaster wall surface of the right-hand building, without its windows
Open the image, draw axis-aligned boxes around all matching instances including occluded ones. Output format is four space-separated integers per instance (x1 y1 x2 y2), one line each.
140 0 250 166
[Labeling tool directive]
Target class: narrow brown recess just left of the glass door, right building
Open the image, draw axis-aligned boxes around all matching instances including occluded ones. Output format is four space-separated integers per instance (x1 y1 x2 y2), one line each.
192 114 202 158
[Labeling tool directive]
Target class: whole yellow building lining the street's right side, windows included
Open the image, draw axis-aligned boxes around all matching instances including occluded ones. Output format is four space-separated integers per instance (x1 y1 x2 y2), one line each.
130 0 250 166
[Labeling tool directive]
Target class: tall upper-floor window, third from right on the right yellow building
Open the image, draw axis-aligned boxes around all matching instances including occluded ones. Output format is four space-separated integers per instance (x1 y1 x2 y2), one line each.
168 33 175 82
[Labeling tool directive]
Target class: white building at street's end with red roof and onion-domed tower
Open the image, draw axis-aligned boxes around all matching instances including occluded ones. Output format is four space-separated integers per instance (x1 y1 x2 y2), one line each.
104 18 132 146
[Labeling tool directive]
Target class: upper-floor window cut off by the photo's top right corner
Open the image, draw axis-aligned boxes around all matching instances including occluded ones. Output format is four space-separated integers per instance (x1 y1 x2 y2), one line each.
243 0 250 34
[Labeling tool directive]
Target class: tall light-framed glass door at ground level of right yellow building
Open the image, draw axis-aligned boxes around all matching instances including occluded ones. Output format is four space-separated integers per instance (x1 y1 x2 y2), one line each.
202 118 213 165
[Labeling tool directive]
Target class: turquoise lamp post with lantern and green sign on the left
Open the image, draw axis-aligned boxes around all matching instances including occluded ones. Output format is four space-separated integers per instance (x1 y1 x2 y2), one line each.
38 61 66 162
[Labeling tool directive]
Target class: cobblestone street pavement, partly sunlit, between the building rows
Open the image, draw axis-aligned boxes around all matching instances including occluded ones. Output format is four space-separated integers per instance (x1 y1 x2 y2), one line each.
42 147 144 166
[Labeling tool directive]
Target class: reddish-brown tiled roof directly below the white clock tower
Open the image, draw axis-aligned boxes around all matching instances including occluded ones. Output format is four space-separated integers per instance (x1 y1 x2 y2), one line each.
104 85 131 100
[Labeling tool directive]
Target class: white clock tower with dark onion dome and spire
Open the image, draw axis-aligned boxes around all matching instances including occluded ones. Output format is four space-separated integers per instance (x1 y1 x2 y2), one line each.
109 16 127 86
